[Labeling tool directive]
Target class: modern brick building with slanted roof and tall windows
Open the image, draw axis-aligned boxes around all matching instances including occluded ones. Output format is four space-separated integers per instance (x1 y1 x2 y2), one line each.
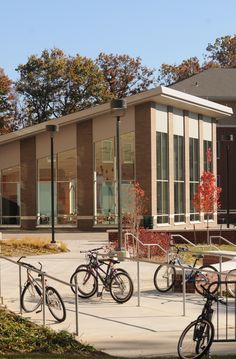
0 86 232 230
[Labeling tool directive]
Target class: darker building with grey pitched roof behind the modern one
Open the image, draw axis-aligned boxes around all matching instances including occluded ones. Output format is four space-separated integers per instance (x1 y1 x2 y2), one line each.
170 68 236 224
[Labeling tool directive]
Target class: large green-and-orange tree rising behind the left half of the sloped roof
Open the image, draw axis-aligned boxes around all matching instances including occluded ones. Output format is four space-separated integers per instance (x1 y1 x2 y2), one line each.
16 48 111 125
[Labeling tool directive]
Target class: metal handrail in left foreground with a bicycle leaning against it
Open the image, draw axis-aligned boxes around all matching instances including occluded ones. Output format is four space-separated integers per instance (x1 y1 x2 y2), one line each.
0 255 79 335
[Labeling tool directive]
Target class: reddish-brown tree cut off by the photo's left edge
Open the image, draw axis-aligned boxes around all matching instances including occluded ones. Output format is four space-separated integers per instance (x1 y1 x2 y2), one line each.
0 68 15 134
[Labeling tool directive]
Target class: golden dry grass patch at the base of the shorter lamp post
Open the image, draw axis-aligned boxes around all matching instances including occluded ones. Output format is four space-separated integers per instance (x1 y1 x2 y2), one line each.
0 236 68 257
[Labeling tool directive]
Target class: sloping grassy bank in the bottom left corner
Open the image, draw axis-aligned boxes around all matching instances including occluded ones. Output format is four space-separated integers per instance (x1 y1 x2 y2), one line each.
0 308 101 358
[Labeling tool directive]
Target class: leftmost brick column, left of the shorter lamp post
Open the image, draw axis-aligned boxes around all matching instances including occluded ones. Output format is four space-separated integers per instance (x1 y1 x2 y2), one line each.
20 137 37 229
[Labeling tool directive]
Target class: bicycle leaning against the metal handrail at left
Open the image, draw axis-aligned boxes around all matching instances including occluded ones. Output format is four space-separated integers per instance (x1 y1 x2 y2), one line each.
18 256 66 323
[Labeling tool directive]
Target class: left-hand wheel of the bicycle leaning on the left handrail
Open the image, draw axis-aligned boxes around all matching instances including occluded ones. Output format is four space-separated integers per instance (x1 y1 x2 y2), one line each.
20 280 42 313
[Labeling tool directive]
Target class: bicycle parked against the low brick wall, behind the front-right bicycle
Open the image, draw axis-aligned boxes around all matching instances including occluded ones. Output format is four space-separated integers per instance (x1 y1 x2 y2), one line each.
153 245 220 294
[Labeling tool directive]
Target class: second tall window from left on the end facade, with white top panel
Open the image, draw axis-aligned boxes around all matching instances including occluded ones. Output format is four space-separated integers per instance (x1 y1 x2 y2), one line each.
173 109 185 222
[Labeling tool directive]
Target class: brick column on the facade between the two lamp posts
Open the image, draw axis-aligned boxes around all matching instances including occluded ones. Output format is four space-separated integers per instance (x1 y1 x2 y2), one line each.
77 119 94 230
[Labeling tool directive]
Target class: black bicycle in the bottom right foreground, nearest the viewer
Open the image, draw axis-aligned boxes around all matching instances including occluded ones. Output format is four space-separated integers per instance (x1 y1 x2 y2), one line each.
177 284 226 359
